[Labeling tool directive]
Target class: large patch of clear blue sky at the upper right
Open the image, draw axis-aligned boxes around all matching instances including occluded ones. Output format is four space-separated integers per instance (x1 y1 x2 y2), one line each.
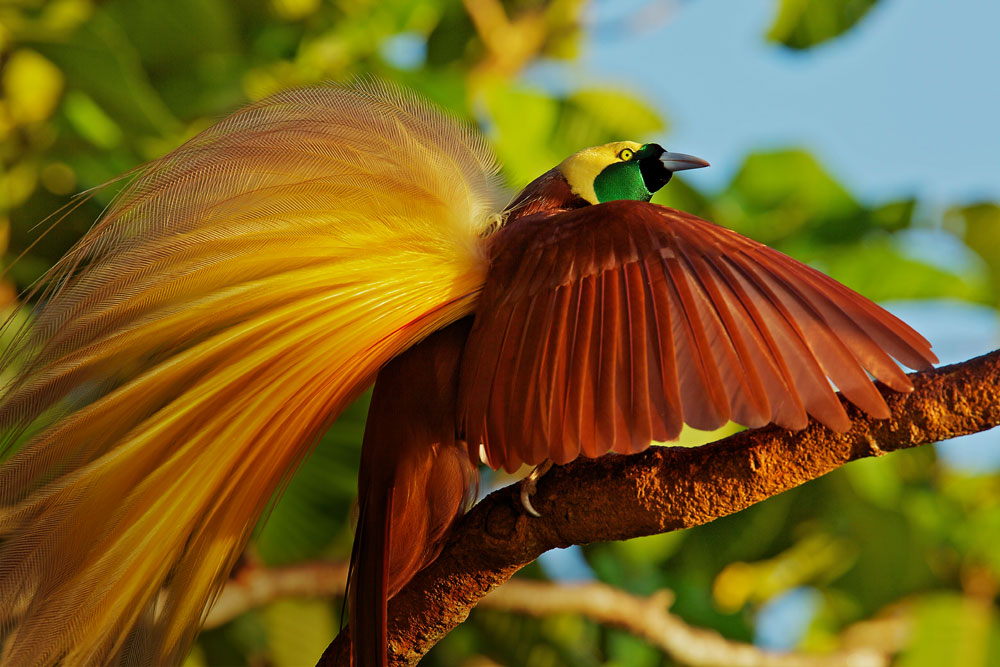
576 0 1000 205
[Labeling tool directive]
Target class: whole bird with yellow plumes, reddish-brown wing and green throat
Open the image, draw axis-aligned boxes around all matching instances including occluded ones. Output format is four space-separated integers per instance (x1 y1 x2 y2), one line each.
0 80 937 667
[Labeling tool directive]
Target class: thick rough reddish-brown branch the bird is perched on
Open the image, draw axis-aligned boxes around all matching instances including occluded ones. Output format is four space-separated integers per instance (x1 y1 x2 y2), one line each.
319 351 1000 666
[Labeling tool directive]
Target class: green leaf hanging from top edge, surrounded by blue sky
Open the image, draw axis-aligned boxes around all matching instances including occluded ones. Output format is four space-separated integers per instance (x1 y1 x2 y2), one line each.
767 0 876 49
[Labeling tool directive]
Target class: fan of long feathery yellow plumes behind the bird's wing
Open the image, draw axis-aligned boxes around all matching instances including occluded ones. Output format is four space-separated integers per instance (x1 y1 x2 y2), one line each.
0 83 496 665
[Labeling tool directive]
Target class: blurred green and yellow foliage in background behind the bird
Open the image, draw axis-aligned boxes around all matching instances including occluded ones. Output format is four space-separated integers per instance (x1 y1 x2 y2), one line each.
0 0 1000 667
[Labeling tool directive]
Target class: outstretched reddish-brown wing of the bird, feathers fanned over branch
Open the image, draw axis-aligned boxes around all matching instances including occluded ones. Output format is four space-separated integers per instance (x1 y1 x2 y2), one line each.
458 201 937 470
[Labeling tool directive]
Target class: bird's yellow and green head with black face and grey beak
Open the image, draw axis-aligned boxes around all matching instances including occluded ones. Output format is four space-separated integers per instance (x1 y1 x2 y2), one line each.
557 141 708 204
